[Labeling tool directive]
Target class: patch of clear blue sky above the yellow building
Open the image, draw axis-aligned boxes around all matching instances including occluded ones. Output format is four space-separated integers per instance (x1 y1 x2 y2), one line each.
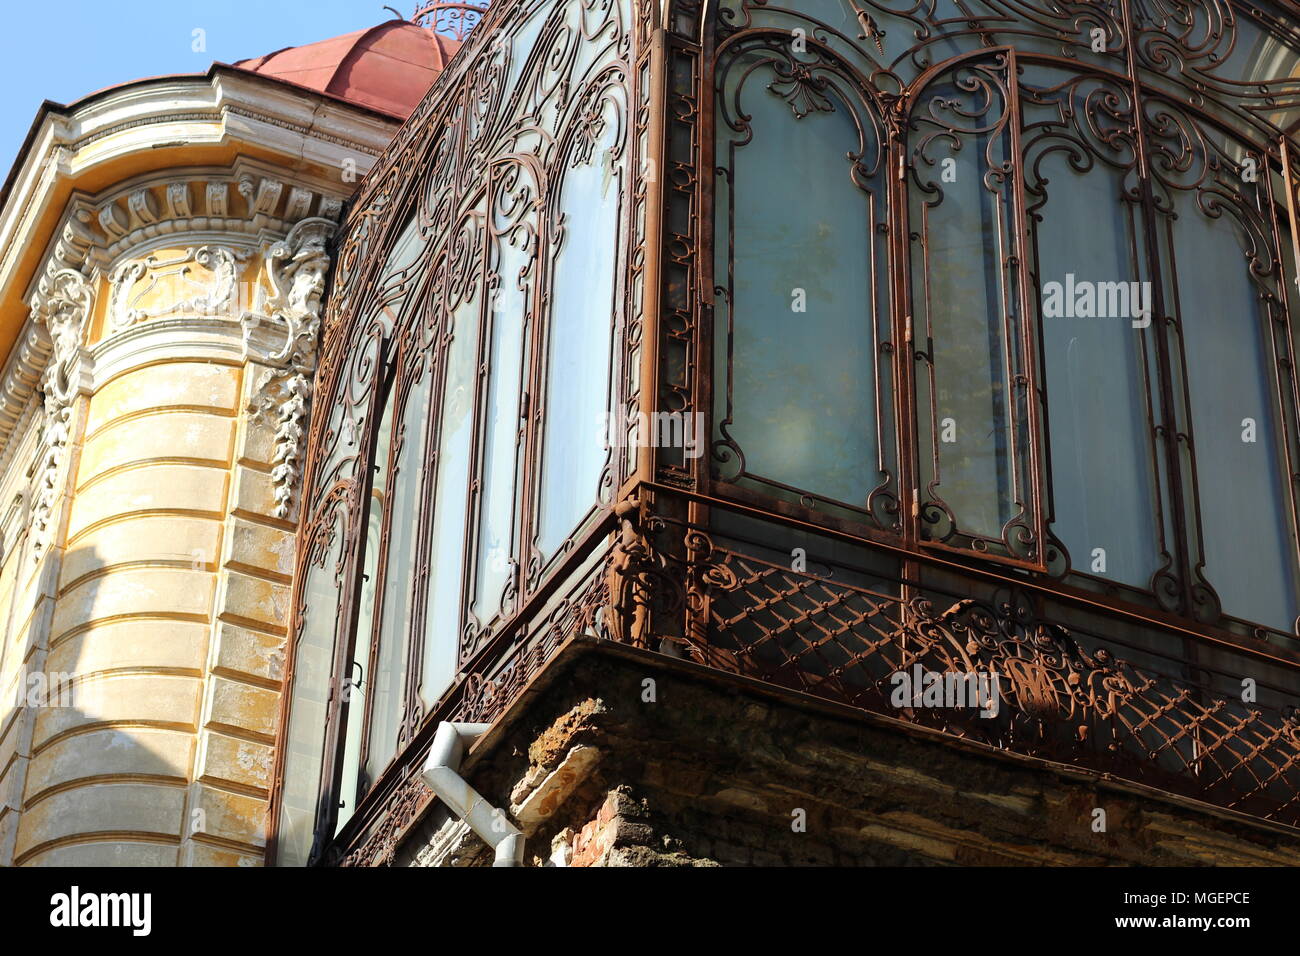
0 0 415 170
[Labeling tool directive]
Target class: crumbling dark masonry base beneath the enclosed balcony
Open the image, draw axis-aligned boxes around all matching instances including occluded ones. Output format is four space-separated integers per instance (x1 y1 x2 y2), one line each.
395 643 1300 866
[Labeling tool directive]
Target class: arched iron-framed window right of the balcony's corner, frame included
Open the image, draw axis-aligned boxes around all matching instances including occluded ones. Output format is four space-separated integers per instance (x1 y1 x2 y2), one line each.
712 34 897 527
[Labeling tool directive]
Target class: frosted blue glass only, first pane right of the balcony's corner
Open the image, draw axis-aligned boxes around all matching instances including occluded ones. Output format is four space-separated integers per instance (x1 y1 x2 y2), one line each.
715 74 880 507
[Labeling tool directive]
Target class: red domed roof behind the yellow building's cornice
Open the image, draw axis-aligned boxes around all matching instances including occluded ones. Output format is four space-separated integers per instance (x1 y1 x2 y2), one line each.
235 20 460 120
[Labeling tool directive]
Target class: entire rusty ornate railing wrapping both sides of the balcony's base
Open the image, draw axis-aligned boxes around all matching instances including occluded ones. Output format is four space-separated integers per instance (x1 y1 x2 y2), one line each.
343 493 1300 865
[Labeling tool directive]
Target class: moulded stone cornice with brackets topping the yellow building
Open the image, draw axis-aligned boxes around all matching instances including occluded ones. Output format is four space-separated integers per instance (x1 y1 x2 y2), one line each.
0 65 397 476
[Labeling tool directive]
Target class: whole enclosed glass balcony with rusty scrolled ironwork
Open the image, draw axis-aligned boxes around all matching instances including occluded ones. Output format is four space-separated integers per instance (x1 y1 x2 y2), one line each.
273 0 1300 865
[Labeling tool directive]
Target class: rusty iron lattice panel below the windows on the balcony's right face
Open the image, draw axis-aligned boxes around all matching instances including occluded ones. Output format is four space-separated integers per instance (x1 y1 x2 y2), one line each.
688 549 1300 826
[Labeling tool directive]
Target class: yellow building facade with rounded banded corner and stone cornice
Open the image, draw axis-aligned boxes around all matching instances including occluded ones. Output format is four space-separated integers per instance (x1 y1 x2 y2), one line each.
0 59 398 865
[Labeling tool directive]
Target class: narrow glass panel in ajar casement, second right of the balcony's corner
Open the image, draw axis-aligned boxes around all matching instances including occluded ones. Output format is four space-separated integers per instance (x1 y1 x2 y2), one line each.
909 68 1026 540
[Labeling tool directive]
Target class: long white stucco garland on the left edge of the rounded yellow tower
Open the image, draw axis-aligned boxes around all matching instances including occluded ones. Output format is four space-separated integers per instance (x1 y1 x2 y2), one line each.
31 269 95 561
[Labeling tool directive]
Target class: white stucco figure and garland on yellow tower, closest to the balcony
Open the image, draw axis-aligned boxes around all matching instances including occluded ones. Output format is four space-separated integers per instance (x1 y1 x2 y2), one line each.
243 219 335 519
